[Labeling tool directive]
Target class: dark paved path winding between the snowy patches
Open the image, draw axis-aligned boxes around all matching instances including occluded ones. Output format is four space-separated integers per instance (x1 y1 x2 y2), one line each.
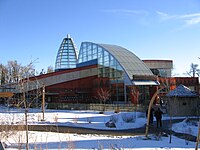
0 119 196 142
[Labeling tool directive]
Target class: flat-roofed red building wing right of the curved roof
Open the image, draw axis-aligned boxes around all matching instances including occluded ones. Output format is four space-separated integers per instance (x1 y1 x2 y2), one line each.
143 60 199 101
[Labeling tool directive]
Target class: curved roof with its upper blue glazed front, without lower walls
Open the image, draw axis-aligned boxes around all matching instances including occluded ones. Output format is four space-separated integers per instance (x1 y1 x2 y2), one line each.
78 42 154 84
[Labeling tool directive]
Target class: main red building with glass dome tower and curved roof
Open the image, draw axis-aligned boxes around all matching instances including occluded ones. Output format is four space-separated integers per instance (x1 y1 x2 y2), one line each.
12 36 159 104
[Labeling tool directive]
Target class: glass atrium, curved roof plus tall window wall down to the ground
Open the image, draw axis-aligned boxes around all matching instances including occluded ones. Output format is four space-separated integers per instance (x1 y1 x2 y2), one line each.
77 42 153 102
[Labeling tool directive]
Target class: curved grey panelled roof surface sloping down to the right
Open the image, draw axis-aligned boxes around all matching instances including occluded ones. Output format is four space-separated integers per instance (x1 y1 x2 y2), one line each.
98 44 154 80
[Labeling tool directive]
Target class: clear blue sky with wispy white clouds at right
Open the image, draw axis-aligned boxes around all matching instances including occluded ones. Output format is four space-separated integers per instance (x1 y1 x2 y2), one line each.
0 0 200 76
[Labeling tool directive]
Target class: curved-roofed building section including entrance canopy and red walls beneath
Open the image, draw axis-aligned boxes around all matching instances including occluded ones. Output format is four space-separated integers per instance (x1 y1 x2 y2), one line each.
77 42 158 103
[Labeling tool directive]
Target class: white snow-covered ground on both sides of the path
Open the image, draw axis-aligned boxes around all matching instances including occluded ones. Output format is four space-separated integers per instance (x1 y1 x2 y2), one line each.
0 106 198 150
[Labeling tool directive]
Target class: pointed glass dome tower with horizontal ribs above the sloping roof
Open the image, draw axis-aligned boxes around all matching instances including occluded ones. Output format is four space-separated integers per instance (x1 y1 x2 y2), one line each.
55 34 77 71
